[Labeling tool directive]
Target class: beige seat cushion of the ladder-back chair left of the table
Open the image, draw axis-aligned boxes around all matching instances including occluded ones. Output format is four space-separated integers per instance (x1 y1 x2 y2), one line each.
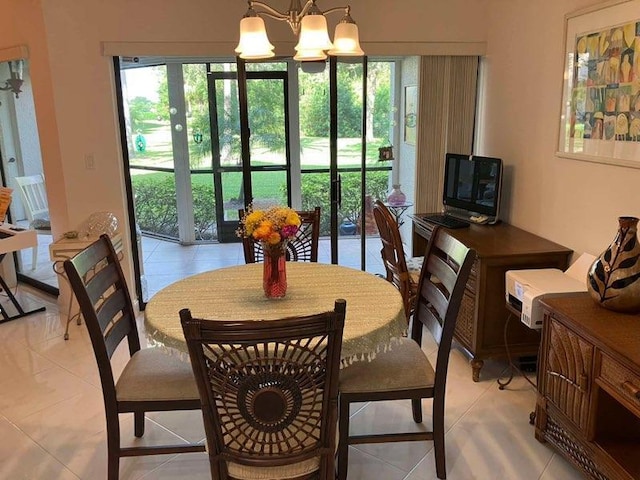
116 348 200 402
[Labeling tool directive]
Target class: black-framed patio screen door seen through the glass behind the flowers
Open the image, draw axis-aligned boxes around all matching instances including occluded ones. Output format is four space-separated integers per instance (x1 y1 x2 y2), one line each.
209 64 291 242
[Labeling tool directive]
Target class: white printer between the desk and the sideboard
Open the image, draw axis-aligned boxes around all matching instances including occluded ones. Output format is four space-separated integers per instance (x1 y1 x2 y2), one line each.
505 253 596 330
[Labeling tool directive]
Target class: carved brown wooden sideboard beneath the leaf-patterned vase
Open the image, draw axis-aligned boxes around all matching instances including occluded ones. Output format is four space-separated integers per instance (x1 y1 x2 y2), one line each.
535 293 640 480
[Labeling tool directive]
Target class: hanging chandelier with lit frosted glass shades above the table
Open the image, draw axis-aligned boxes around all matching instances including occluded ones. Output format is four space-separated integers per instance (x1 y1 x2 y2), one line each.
235 0 364 61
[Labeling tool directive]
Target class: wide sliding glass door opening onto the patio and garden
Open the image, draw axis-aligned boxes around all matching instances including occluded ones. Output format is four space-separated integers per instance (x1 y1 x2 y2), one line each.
116 58 395 304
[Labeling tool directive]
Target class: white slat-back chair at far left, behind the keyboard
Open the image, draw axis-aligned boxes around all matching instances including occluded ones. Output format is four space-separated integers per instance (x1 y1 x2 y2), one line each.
15 173 51 270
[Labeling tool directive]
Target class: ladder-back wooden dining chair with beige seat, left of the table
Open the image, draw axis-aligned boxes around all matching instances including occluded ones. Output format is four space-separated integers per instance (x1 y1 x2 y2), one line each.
64 234 205 480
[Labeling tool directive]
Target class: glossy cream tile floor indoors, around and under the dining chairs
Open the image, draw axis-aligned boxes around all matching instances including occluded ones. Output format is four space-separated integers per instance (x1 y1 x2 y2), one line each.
0 285 582 480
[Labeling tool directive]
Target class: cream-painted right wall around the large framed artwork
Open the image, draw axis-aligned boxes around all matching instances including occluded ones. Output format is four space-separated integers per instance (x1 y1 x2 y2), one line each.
477 0 640 254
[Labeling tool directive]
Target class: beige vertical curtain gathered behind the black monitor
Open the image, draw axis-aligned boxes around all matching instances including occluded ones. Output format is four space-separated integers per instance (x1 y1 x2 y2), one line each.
415 56 479 213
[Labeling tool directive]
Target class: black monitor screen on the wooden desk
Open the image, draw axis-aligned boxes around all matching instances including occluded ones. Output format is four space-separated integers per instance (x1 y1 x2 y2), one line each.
443 153 502 217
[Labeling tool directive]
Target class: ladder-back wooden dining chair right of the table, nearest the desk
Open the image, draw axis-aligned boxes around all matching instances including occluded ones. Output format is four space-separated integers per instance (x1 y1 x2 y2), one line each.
338 229 476 480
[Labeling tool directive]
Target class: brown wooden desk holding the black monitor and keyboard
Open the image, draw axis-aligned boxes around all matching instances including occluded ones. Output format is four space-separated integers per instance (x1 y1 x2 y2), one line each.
411 214 572 382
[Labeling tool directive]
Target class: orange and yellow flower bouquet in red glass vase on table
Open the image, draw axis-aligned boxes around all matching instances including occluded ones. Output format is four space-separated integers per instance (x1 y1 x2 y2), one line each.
237 206 300 298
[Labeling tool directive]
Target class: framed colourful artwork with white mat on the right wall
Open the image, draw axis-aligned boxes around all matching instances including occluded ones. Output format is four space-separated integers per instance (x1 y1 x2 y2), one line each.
556 0 640 168
